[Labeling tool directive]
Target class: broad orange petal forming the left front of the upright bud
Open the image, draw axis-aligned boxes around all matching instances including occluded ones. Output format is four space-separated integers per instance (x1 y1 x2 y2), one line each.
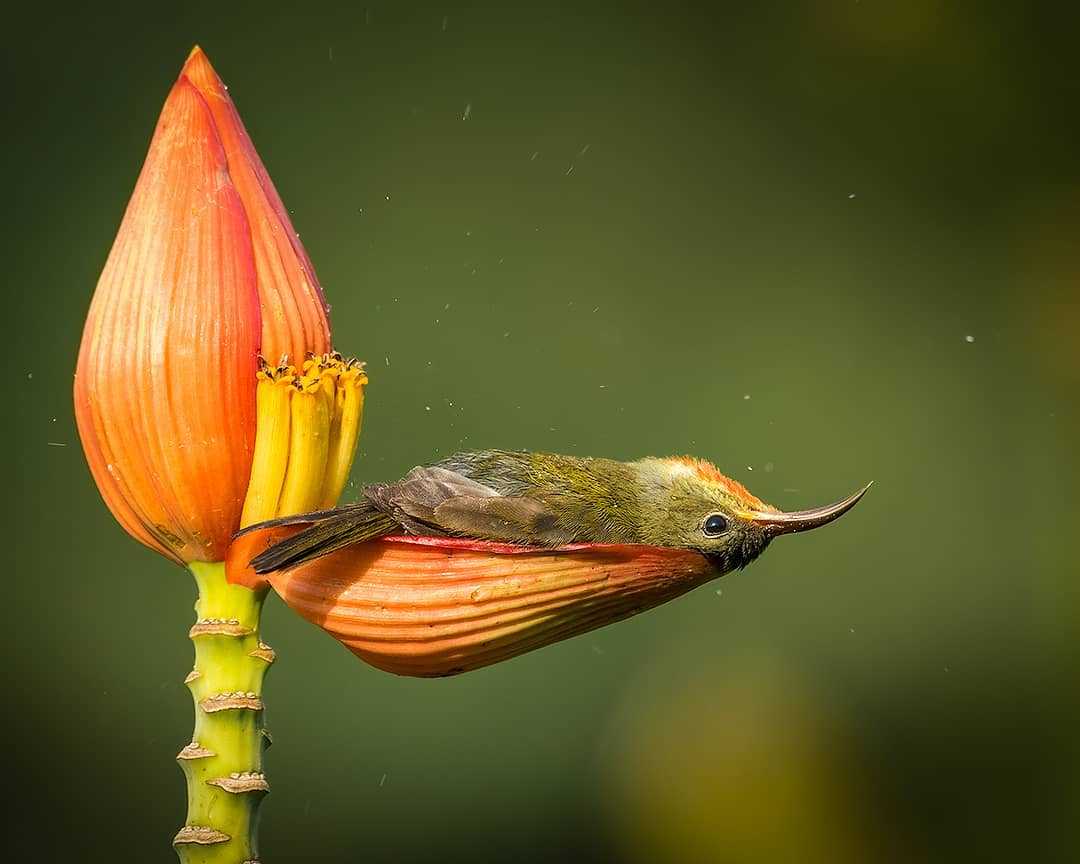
75 77 261 562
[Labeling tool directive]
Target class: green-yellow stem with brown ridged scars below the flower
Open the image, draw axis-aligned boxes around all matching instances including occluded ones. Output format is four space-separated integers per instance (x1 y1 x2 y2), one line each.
173 563 273 864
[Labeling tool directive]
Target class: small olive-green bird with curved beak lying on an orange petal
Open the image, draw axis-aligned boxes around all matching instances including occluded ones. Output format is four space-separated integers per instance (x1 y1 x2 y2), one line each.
241 450 869 573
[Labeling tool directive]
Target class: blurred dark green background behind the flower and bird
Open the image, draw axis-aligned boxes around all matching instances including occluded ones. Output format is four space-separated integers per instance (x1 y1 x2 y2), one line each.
2 0 1080 864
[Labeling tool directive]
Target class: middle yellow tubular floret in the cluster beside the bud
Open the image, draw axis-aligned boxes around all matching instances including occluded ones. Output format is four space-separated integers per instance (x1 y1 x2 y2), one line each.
278 375 330 516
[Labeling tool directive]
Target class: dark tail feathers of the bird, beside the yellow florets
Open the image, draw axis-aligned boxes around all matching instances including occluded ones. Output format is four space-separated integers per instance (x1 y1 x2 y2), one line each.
251 501 401 573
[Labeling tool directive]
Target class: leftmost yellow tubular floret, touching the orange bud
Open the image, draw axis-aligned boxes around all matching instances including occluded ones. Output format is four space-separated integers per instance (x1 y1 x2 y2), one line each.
240 366 293 528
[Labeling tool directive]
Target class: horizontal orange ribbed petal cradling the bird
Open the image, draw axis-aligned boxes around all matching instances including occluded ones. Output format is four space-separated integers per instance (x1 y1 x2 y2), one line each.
233 531 716 677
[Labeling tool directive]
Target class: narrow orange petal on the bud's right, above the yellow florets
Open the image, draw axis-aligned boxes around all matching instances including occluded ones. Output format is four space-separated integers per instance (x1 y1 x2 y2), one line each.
181 48 330 364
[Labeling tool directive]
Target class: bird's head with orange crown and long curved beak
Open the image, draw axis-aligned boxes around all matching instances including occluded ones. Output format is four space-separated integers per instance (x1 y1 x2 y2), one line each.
637 456 869 572
